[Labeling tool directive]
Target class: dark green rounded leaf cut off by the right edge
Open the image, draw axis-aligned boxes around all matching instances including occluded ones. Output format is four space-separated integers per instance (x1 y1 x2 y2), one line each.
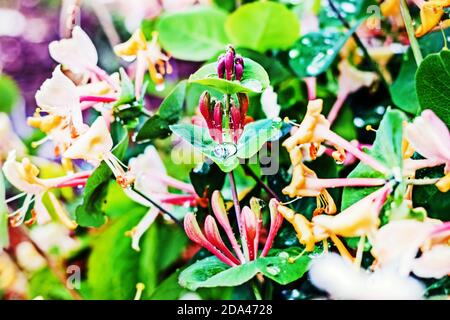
416 50 450 125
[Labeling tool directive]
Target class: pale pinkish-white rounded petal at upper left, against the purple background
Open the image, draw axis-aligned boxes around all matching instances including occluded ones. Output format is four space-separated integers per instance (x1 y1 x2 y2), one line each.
48 26 98 73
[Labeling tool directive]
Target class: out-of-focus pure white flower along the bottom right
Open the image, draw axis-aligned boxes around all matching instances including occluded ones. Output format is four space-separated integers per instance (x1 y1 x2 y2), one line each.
308 253 425 300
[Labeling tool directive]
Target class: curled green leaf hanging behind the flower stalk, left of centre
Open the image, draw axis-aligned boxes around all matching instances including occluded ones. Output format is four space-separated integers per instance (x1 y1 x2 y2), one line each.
75 127 128 227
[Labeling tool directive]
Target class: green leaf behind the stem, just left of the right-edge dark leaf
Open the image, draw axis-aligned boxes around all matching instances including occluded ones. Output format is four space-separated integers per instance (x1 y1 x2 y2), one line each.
389 53 420 115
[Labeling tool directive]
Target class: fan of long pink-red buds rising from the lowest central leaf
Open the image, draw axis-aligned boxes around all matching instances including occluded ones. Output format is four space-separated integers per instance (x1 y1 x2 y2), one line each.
184 190 283 267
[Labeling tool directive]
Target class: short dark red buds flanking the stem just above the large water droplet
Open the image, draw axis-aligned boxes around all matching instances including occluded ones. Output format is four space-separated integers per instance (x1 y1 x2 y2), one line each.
199 91 251 143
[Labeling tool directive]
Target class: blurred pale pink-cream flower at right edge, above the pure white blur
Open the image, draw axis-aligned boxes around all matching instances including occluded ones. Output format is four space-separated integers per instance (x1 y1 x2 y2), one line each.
371 218 450 278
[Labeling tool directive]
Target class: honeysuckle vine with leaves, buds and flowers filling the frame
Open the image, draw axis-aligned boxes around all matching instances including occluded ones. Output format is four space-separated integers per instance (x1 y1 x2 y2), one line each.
0 0 450 300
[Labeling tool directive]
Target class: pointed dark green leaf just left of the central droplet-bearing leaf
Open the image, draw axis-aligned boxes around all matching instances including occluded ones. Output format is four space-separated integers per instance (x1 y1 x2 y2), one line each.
136 80 187 141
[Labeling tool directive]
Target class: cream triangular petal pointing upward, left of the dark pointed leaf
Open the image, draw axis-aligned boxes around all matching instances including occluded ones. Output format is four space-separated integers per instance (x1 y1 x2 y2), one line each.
64 117 113 161
